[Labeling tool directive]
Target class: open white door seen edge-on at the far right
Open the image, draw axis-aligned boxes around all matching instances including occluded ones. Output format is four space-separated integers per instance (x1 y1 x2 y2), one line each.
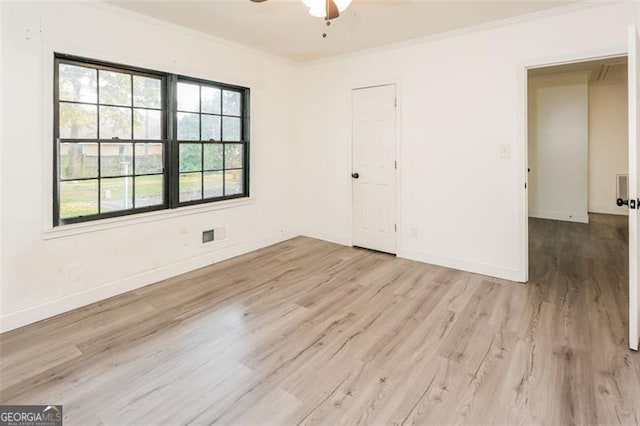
629 27 640 351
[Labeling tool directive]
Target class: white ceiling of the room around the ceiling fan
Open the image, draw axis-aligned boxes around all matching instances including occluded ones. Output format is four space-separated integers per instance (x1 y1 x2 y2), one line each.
104 0 577 62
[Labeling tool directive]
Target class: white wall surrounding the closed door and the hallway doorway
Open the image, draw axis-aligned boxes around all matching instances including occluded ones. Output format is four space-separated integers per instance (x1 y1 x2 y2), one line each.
300 2 637 280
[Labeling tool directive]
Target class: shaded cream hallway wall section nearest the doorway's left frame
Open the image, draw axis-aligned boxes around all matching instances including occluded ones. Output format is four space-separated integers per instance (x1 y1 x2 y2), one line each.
528 72 589 223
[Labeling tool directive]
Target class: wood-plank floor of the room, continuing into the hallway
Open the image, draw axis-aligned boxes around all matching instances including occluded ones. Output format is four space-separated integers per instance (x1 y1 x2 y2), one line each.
0 215 640 425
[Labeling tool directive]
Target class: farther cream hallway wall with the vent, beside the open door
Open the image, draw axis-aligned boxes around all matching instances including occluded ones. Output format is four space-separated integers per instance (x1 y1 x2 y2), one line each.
589 72 629 215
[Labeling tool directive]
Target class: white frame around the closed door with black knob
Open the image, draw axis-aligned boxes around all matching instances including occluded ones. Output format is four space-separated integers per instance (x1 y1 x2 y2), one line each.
345 78 402 251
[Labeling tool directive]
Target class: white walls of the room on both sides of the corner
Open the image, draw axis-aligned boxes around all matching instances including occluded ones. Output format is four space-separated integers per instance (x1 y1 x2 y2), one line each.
0 2 637 331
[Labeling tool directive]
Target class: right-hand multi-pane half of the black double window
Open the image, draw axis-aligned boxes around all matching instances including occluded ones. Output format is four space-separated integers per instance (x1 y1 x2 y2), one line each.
176 80 245 203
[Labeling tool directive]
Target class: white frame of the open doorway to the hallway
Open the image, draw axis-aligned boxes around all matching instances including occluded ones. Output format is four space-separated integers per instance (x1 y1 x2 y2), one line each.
517 50 629 283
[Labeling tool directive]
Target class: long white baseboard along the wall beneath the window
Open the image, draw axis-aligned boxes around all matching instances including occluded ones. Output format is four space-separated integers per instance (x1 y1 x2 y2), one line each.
0 232 299 333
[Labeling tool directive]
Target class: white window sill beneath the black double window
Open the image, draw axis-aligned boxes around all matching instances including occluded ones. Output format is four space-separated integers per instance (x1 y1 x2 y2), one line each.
42 197 255 240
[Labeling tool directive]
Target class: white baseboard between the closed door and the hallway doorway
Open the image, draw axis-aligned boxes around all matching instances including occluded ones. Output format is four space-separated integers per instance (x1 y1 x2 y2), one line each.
397 250 525 282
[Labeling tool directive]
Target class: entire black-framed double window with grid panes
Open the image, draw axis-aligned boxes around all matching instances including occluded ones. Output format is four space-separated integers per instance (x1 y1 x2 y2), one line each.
53 54 249 226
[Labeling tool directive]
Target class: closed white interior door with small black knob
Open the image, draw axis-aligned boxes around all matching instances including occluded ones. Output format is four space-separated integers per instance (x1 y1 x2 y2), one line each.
351 85 396 253
